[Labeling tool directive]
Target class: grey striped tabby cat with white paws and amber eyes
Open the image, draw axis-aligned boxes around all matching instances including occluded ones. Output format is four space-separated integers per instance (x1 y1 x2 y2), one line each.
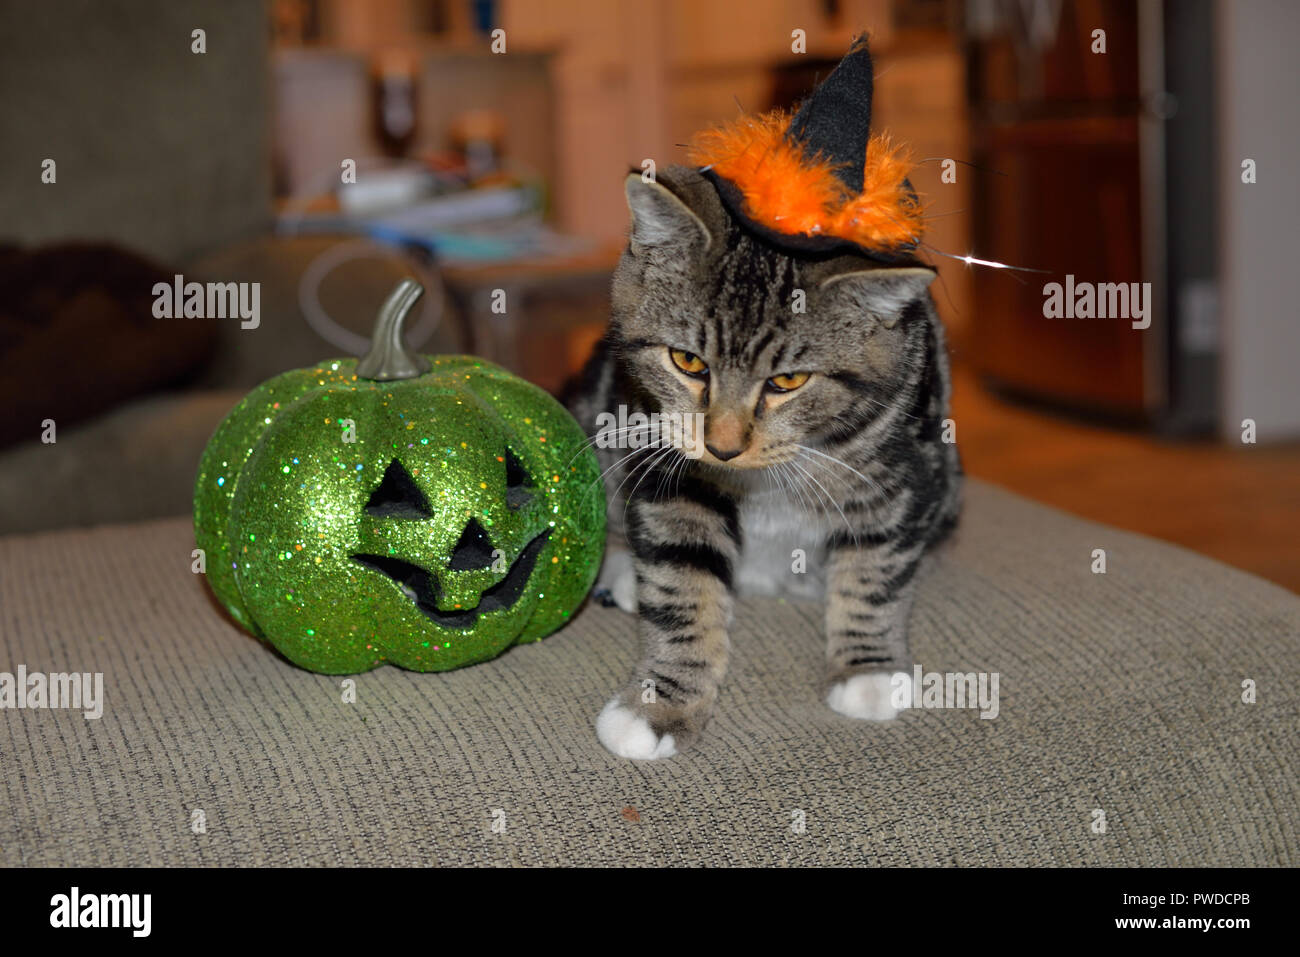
564 165 962 758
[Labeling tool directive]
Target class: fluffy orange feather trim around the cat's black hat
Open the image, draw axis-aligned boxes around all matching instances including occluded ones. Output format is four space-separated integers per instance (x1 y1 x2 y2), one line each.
688 111 924 248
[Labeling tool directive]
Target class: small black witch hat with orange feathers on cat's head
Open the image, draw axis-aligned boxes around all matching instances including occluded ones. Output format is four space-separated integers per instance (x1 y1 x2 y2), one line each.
689 36 923 263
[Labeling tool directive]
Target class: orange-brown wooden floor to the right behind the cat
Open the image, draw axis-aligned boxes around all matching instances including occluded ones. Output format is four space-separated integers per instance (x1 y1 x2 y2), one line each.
953 368 1300 592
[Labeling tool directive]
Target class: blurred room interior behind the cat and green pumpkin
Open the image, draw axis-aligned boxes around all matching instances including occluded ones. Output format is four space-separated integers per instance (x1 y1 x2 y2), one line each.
0 0 1300 590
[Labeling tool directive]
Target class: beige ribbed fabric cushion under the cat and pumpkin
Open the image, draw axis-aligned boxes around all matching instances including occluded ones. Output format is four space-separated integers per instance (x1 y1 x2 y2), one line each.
0 482 1300 866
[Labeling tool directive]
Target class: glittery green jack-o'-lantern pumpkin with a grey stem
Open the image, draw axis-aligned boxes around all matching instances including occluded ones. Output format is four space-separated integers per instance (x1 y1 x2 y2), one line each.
194 281 605 675
